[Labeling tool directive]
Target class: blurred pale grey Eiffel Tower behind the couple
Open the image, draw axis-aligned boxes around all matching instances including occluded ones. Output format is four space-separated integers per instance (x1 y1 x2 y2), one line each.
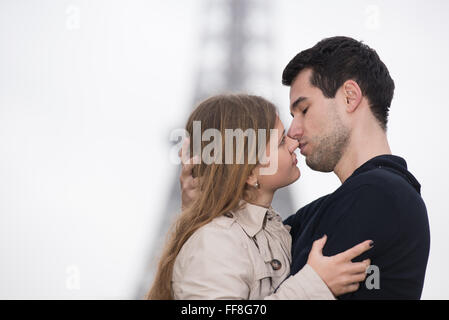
136 0 294 299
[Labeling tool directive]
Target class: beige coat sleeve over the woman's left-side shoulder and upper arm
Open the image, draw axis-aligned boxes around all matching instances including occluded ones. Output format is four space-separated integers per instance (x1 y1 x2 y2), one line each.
172 212 254 299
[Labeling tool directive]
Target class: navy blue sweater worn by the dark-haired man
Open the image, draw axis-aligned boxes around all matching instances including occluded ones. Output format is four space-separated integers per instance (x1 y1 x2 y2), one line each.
284 155 430 299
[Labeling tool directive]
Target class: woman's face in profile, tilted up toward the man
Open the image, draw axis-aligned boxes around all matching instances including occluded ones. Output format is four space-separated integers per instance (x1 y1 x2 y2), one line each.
256 118 301 191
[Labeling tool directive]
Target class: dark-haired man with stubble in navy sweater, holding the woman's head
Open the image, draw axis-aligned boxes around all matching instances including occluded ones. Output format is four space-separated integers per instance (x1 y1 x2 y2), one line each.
181 37 430 299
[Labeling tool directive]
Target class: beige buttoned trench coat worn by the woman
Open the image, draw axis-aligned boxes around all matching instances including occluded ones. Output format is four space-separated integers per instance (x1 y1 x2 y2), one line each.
172 201 335 300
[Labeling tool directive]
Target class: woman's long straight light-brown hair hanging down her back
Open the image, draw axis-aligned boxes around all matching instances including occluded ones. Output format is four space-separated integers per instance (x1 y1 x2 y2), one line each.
145 94 277 300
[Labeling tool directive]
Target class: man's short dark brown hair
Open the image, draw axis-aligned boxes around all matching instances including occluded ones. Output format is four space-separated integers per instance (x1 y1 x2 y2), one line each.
282 37 394 130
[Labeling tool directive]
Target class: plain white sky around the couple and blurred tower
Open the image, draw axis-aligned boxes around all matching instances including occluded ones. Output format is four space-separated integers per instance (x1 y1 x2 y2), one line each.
0 0 449 299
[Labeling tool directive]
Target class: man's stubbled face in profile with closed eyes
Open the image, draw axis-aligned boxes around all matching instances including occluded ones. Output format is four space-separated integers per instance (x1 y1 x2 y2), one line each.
287 69 350 172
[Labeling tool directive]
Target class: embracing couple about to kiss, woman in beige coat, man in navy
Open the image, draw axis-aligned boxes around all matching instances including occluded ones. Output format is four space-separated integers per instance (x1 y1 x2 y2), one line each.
146 36 430 300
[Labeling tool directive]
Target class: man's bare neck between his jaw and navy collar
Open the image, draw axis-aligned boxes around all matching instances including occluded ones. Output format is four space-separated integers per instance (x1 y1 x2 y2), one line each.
334 127 391 183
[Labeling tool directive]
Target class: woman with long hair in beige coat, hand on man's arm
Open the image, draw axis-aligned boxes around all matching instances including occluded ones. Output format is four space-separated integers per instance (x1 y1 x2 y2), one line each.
147 95 370 299
